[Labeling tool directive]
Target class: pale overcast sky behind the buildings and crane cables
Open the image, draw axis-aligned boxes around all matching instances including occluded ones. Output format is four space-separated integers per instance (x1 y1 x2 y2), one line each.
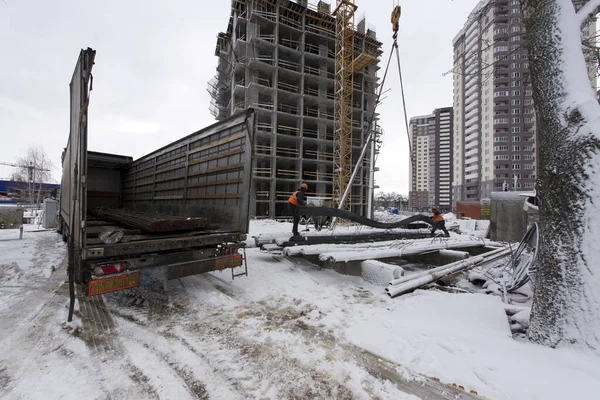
0 0 478 194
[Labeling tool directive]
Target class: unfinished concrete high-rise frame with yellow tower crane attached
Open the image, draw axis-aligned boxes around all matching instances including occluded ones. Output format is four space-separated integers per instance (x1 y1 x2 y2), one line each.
209 0 381 217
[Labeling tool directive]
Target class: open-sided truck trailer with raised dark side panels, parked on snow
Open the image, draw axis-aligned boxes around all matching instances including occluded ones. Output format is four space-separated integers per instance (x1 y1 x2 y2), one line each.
59 48 255 296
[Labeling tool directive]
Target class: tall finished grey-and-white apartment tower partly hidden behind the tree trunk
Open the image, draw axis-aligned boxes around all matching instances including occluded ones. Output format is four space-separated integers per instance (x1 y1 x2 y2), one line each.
452 0 595 208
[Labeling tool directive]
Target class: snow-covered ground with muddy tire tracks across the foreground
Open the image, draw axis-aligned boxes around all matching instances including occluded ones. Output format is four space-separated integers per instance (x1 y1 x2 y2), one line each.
0 221 600 399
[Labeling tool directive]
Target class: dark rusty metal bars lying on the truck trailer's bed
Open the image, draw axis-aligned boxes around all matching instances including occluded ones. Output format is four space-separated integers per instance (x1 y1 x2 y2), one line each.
94 207 211 232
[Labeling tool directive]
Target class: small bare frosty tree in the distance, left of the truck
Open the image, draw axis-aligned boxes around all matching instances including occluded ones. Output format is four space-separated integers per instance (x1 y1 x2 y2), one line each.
17 145 53 204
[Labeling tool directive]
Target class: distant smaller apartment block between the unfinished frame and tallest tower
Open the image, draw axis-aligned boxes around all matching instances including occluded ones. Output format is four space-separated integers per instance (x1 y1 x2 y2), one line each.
408 107 454 211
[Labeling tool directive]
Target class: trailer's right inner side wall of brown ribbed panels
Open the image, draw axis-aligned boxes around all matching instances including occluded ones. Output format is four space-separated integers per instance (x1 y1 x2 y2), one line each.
122 109 256 234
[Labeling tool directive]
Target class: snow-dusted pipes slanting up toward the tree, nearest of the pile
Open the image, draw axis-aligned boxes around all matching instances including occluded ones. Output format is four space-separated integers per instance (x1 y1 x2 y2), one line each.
385 248 510 297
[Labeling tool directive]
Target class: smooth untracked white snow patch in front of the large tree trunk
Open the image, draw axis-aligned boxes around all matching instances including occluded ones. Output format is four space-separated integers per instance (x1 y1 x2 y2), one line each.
347 291 600 399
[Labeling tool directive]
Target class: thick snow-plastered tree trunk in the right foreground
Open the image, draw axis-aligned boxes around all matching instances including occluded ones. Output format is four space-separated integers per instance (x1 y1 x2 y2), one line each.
522 0 600 352
